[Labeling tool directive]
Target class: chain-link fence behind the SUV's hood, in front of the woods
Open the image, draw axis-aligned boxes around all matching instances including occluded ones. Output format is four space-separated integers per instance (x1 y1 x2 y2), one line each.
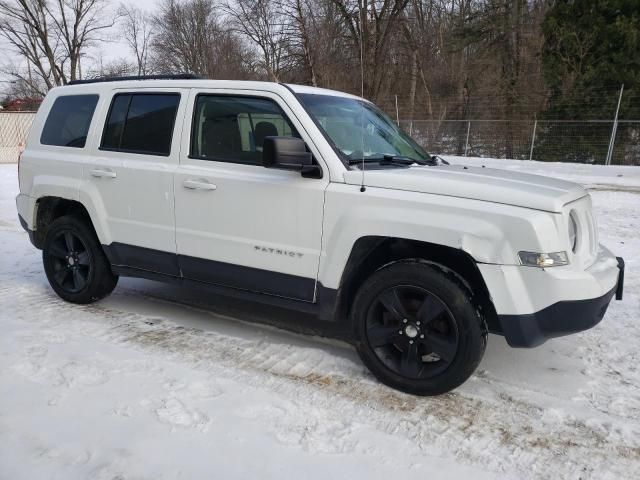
400 120 640 165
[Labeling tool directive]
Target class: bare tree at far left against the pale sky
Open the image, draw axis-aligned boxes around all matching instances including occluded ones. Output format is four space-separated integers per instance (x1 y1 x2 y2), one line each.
0 0 115 89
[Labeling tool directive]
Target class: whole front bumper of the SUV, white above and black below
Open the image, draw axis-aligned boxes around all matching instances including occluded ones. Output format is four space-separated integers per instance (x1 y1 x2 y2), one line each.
479 247 624 347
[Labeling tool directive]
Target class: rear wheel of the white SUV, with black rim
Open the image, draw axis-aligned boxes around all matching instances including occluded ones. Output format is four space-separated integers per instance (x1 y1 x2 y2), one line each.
42 215 118 304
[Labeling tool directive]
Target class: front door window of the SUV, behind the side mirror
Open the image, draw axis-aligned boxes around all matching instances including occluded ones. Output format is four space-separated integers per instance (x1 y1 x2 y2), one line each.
191 95 299 165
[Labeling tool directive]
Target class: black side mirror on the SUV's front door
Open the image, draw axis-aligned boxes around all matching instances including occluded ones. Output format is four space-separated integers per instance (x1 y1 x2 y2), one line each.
262 137 322 178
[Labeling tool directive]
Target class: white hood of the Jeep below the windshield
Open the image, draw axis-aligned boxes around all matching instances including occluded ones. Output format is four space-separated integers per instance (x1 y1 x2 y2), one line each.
344 165 587 213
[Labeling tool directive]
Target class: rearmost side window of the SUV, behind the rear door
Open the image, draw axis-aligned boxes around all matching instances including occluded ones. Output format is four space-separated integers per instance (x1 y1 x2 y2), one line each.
40 95 98 148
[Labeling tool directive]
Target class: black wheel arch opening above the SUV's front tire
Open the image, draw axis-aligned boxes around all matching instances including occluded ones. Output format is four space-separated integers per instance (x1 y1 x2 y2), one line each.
335 236 500 332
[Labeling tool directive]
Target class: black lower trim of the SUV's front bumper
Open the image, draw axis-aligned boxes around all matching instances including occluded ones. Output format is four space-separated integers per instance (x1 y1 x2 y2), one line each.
498 286 617 348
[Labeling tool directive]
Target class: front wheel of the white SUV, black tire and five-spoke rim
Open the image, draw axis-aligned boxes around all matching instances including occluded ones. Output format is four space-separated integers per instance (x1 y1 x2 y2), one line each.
351 260 487 395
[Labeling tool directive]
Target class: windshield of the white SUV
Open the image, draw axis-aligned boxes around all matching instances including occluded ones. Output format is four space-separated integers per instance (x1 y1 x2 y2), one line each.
298 94 430 165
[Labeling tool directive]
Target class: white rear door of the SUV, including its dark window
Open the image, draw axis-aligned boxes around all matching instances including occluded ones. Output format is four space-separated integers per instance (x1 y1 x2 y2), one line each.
84 88 188 276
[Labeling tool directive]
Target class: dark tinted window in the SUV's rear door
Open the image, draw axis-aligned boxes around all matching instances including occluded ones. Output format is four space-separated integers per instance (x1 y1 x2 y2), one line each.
100 93 180 156
